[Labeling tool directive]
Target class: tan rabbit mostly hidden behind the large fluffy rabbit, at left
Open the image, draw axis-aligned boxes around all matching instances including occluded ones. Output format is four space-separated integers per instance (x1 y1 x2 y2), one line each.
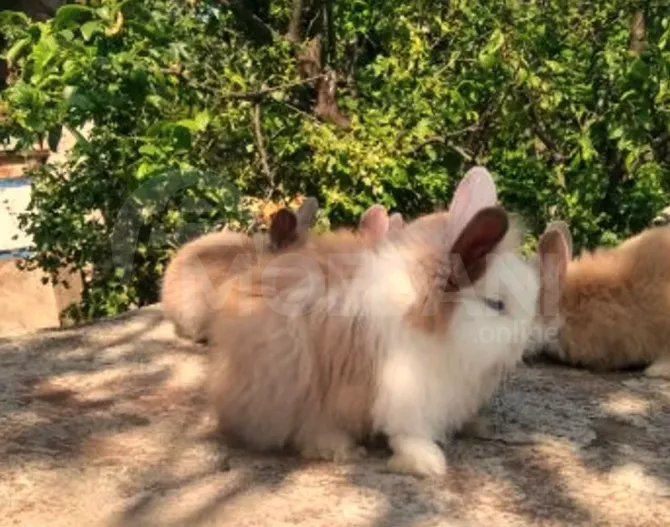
161 198 319 342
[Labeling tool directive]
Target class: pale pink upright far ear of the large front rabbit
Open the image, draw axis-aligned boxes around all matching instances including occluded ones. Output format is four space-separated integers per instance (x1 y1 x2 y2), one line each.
447 166 498 243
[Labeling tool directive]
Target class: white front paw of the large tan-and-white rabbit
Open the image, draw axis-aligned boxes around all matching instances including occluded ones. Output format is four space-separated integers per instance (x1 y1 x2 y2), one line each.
388 437 447 477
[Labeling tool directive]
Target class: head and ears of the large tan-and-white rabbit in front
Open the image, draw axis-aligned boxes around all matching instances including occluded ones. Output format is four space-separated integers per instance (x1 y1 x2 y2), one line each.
384 167 539 388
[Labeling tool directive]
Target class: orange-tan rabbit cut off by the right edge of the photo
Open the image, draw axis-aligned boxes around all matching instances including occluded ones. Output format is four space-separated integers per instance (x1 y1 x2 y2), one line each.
528 222 670 378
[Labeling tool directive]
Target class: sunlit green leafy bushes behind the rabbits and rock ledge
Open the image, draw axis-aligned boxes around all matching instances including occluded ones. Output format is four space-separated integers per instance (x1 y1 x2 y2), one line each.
0 0 670 324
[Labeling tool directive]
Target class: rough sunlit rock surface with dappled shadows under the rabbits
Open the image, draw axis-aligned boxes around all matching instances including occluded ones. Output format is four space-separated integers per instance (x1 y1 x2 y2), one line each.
0 306 670 527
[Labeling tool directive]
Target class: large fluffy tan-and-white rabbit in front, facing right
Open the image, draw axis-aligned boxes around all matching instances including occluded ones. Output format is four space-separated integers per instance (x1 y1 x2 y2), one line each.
209 167 539 475
